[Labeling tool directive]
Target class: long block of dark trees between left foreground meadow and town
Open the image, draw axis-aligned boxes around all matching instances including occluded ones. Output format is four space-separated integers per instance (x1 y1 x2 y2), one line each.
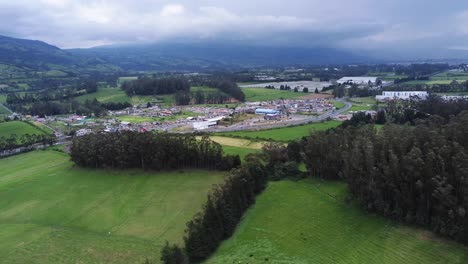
71 131 240 170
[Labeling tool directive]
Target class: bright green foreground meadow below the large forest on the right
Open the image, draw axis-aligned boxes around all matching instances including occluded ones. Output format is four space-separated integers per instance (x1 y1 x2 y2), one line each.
206 180 468 264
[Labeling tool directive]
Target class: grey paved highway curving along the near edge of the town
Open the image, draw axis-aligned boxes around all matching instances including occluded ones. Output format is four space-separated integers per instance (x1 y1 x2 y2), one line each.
204 99 353 132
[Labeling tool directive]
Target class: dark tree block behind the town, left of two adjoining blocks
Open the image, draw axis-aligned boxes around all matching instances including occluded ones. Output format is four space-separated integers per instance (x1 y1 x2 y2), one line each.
122 77 190 96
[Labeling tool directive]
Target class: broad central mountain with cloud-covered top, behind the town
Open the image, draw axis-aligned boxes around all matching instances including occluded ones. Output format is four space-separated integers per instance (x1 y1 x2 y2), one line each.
69 42 368 70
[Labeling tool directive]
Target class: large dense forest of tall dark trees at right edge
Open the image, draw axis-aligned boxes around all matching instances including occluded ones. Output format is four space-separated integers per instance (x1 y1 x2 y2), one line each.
303 112 468 244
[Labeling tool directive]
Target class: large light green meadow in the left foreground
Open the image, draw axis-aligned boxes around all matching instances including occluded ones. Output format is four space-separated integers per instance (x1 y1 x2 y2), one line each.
0 150 223 263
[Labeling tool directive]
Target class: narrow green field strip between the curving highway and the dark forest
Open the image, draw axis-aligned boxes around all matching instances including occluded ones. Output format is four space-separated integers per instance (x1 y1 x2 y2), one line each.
217 121 341 142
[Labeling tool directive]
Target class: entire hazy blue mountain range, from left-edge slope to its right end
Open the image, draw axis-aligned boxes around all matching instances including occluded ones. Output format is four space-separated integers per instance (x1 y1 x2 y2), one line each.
0 36 369 71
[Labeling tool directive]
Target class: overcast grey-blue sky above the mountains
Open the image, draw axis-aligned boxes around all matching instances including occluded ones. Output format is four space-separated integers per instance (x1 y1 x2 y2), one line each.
0 0 468 57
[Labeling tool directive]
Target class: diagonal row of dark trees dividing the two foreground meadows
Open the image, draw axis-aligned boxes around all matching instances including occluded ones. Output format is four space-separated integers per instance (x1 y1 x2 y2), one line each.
161 155 268 264
